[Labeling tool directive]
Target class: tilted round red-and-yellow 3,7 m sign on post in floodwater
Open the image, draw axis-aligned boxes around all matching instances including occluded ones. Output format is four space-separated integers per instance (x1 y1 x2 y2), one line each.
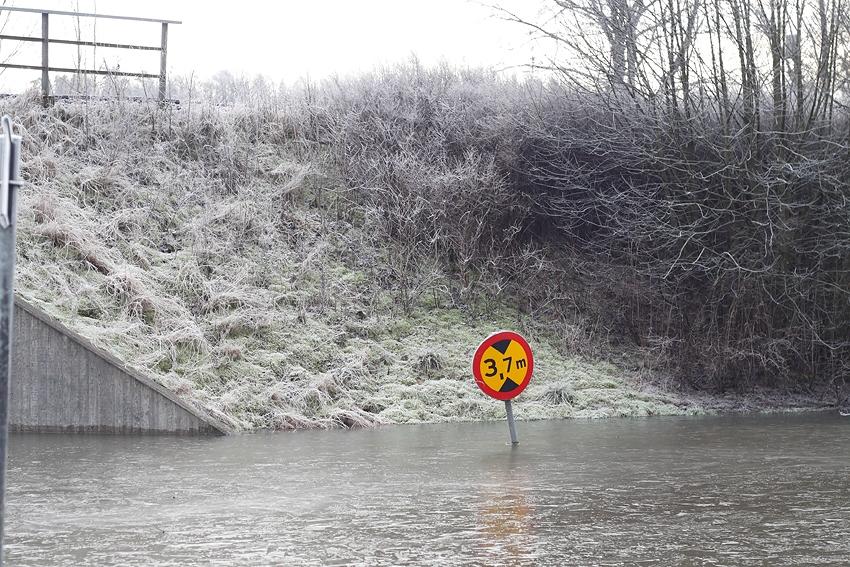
472 331 534 445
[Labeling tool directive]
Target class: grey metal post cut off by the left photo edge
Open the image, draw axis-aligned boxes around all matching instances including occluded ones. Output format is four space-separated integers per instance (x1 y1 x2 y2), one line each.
0 116 21 565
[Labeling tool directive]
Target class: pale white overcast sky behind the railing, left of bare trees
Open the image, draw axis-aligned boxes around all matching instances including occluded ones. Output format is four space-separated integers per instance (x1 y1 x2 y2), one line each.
0 0 540 91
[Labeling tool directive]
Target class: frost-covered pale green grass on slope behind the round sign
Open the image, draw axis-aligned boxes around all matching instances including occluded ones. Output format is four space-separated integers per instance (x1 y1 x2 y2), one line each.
3 93 828 430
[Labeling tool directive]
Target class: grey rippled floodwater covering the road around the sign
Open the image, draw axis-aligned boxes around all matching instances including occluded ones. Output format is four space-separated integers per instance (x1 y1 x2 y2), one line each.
1 414 850 567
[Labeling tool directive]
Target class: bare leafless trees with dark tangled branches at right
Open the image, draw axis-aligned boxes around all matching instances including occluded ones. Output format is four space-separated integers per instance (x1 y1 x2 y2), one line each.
486 0 850 388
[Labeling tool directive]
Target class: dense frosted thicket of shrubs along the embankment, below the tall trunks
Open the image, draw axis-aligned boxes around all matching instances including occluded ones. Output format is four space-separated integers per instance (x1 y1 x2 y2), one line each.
316 65 850 387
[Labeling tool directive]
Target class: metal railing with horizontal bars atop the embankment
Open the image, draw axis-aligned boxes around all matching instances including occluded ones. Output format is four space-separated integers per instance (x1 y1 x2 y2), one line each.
0 6 182 103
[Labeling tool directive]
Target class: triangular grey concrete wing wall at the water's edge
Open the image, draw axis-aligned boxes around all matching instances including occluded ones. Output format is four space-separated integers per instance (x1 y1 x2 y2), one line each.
9 297 228 435
